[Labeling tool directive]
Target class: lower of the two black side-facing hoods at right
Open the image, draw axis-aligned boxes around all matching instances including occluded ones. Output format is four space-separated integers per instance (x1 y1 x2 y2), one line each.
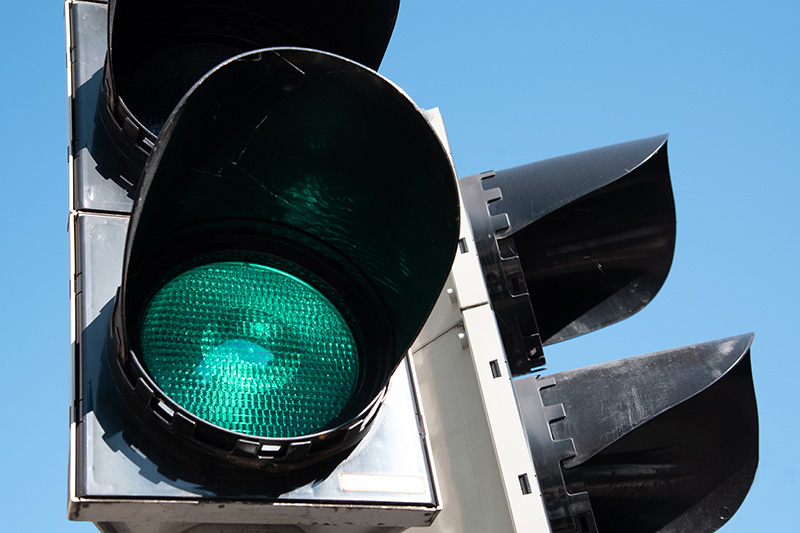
514 334 758 533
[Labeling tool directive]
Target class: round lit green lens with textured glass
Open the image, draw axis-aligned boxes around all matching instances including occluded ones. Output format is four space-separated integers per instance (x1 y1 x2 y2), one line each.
141 262 359 437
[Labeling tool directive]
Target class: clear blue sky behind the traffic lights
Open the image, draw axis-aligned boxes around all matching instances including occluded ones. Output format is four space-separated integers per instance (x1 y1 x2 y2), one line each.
0 0 800 533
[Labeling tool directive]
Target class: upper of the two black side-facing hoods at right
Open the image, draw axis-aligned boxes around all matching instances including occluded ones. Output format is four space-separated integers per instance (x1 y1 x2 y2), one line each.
460 135 675 375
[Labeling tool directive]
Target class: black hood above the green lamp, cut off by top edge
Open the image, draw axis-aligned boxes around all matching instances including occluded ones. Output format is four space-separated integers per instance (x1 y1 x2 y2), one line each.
100 0 400 170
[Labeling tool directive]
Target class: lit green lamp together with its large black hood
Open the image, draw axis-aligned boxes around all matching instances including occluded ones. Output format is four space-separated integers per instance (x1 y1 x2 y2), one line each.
109 48 459 473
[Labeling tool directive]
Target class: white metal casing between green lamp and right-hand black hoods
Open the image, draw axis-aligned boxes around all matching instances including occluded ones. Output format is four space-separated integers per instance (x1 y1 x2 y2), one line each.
411 109 550 533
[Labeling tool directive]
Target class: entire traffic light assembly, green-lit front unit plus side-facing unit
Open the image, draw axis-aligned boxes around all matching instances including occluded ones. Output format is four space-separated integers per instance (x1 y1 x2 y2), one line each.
65 0 757 533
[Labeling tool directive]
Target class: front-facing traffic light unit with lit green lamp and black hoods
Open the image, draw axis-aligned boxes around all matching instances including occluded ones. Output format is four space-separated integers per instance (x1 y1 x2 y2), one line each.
66 0 461 531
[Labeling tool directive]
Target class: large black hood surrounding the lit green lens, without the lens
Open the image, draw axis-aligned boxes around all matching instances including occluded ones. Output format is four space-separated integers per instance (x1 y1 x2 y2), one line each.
110 48 459 474
